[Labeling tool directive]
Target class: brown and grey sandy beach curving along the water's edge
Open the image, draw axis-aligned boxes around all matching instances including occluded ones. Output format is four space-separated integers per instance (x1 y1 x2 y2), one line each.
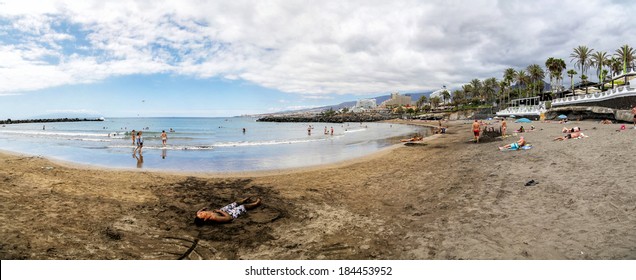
0 121 636 259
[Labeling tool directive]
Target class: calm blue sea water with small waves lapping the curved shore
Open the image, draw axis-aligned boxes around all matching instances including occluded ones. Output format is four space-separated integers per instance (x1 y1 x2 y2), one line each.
0 117 428 172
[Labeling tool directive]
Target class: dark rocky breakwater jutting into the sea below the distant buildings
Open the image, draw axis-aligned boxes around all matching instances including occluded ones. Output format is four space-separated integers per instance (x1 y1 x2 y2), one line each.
256 114 394 123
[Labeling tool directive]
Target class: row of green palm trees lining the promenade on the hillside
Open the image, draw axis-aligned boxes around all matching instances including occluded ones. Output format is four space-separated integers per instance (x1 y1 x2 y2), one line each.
417 45 636 111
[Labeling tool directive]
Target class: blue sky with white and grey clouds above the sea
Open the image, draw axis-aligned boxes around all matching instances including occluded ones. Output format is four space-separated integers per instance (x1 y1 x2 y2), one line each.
0 0 636 119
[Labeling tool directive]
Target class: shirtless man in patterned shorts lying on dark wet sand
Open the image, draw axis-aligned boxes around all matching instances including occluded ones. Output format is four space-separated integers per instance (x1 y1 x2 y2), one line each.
194 197 261 226
